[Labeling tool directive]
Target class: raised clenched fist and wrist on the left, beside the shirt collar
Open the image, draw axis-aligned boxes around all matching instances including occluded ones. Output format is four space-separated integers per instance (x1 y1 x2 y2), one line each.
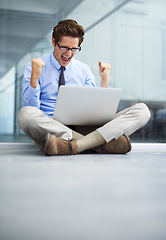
30 58 45 88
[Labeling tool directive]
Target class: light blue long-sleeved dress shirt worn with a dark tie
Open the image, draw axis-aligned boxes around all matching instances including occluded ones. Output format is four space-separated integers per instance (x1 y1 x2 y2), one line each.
23 53 95 117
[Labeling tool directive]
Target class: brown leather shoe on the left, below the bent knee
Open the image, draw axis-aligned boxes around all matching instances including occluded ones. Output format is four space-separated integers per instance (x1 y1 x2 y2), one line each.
44 134 77 156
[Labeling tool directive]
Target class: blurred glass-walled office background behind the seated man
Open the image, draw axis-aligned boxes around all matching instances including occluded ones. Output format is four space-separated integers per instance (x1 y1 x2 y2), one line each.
0 0 166 142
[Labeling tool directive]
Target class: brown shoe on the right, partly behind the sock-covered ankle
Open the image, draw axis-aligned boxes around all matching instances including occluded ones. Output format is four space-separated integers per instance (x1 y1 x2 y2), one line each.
95 135 131 154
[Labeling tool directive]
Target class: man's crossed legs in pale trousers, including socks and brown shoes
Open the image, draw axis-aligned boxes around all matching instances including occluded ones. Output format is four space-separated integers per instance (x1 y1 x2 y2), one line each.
17 103 150 155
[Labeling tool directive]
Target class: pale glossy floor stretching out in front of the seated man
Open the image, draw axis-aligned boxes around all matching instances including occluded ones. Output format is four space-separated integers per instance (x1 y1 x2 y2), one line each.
0 143 166 240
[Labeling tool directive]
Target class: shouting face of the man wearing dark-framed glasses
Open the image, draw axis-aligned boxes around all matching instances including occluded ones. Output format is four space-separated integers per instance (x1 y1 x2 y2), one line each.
52 36 79 67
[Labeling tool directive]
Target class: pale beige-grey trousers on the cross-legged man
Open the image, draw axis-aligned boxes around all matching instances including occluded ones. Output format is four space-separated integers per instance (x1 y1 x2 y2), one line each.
17 103 150 150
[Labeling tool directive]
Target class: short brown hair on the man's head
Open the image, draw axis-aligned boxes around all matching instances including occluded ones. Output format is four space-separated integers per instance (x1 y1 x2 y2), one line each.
52 19 84 46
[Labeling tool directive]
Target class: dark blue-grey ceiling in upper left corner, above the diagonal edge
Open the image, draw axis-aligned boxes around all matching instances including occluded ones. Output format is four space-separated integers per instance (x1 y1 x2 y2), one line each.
0 0 82 79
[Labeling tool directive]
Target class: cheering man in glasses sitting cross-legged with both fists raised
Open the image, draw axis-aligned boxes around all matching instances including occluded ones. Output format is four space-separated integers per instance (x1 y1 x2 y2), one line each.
18 20 150 155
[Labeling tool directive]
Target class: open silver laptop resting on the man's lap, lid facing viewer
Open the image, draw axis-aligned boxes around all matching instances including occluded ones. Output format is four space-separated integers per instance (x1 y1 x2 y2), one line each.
53 86 122 125
